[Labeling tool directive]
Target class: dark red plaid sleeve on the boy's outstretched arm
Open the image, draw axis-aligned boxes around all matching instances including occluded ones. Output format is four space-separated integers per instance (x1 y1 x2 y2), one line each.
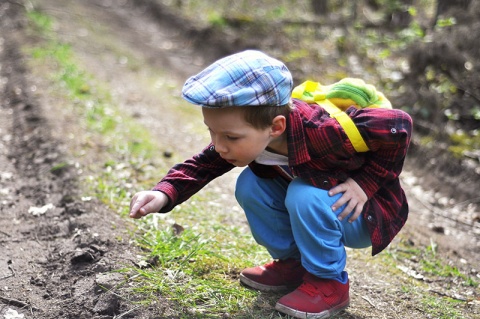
153 144 235 213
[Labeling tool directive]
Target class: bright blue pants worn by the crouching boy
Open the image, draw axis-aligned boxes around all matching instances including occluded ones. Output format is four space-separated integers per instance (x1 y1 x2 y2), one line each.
235 168 371 282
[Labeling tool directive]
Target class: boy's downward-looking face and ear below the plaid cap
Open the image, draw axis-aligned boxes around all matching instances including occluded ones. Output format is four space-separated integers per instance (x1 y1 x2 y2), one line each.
202 107 275 167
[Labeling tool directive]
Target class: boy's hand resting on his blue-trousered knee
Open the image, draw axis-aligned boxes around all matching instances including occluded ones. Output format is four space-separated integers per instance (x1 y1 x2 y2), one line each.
328 178 368 223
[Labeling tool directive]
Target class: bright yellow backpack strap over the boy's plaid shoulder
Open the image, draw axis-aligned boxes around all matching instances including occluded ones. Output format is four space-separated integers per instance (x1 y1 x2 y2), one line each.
316 100 369 152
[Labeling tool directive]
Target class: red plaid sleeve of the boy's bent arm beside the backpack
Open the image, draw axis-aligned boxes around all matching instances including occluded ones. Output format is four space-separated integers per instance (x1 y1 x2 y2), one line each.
351 109 412 198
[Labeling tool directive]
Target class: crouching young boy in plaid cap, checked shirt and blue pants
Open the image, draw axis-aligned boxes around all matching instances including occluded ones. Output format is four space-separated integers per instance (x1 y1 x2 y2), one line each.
130 50 412 318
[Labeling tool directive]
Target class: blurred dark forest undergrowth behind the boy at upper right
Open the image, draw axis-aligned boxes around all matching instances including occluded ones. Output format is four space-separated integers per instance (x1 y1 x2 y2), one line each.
147 0 480 199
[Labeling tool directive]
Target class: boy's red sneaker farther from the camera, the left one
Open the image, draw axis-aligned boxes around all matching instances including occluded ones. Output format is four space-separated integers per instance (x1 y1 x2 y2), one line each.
240 259 307 291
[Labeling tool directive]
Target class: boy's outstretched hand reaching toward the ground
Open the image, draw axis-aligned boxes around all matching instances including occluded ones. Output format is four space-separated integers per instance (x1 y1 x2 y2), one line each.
130 191 168 219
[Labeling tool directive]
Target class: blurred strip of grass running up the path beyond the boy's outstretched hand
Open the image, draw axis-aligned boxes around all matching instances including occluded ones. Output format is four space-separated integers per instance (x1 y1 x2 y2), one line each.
27 11 161 214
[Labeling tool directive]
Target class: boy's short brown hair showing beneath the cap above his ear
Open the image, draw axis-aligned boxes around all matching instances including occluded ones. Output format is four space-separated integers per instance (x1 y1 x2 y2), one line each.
240 101 292 129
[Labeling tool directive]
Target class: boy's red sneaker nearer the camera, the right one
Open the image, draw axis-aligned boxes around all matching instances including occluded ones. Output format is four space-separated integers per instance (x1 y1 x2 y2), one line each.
275 273 350 319
